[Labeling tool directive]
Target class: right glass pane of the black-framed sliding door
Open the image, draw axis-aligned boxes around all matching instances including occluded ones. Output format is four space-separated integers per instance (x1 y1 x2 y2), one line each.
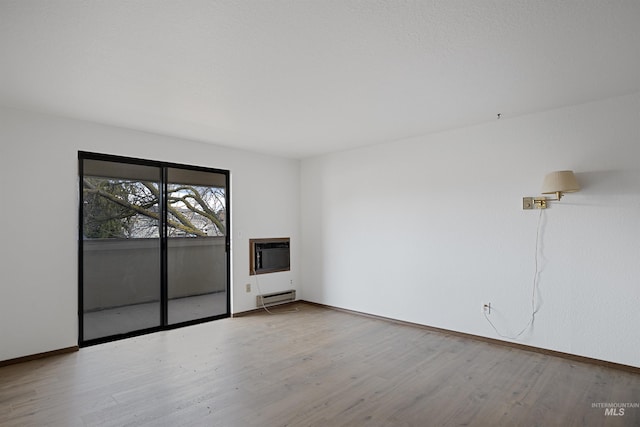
167 168 228 324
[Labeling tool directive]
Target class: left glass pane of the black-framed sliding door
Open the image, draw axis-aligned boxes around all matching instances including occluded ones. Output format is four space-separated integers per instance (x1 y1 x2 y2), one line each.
82 159 161 341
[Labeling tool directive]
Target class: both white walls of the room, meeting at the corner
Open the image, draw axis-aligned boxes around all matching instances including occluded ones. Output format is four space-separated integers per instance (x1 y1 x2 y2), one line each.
0 94 640 366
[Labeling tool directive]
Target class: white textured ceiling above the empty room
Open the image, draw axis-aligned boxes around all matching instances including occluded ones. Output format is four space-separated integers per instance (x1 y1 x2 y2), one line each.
0 0 640 158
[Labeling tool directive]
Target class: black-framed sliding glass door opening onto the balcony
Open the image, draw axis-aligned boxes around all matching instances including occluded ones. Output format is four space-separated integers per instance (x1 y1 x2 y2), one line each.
79 152 230 345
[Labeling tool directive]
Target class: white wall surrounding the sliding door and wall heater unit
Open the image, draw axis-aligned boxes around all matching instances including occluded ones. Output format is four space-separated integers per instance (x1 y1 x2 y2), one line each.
0 109 300 360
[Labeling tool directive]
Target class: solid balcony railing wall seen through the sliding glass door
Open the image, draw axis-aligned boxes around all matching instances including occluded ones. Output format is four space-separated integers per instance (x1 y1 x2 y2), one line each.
83 236 227 311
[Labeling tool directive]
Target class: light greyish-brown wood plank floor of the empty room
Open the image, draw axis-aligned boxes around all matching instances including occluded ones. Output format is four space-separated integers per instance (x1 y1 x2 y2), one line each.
0 303 640 427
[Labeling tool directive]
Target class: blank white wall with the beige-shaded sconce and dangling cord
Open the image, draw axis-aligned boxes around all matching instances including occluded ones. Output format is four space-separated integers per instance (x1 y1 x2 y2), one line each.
301 93 640 367
